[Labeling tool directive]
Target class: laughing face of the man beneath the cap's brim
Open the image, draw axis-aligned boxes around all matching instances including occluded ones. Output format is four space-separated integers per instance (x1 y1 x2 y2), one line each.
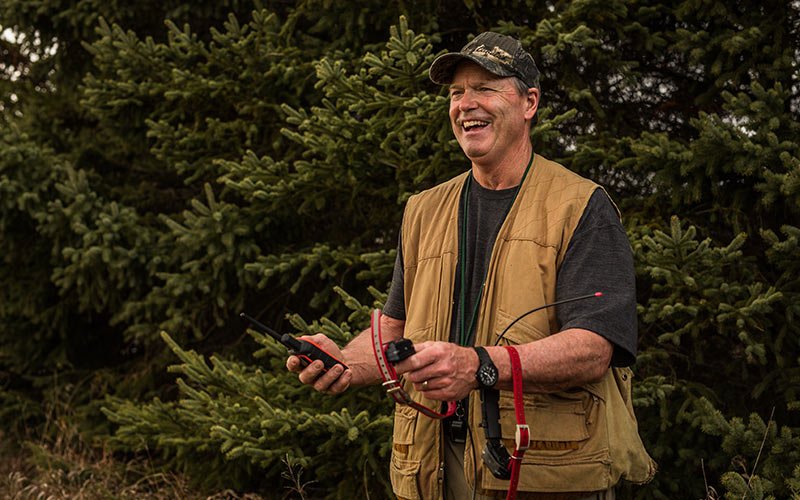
450 62 538 166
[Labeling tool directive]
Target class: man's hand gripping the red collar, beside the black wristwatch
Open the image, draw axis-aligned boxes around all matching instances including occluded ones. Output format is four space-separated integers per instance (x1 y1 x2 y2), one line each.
395 341 478 401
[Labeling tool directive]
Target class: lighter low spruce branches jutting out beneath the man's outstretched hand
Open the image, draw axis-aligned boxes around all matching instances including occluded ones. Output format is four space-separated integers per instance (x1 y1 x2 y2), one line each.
104 294 392 498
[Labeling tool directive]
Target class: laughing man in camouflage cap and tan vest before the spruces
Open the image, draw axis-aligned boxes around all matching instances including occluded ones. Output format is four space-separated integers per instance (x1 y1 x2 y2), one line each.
287 32 655 499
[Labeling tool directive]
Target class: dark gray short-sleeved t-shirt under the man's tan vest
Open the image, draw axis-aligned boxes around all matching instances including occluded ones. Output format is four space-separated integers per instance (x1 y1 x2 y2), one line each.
383 176 638 366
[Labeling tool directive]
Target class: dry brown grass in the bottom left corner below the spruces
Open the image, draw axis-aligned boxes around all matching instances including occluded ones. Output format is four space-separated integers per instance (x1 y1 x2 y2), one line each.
0 378 313 500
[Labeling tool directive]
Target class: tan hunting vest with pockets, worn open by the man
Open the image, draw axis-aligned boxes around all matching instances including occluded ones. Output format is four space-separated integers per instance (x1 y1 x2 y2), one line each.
390 155 656 499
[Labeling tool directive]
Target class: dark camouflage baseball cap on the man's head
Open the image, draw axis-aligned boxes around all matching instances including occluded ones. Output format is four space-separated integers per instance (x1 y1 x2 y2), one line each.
429 31 539 88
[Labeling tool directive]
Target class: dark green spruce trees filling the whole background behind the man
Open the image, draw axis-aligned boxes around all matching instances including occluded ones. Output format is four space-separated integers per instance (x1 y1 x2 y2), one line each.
0 0 800 498
